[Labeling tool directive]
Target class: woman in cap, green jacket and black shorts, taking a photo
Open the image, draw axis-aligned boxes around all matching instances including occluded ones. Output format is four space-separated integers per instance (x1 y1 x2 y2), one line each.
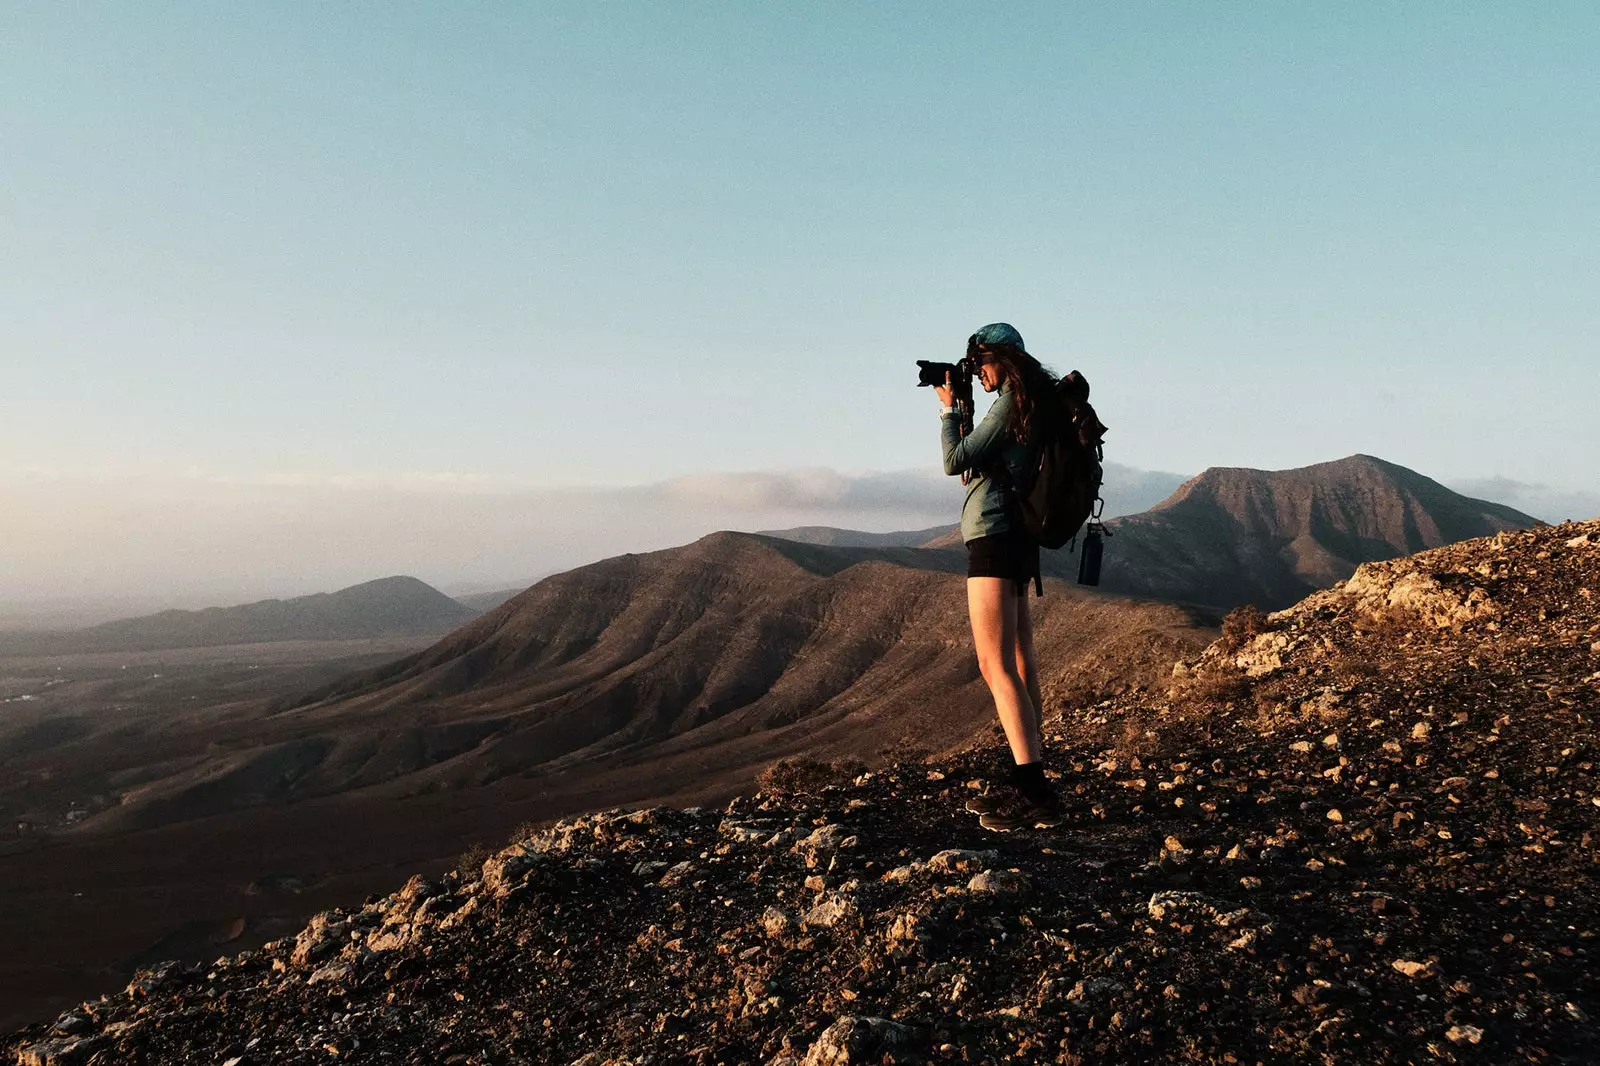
936 322 1061 832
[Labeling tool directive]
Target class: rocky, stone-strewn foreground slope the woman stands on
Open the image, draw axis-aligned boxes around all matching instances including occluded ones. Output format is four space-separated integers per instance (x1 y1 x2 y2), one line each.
12 522 1600 1066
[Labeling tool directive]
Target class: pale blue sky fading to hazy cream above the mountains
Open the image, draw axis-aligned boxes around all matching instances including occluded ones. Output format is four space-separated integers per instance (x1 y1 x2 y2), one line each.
0 0 1600 602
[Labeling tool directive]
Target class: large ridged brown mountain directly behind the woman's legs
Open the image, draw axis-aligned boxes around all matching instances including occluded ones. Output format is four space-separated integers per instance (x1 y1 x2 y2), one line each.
85 533 1216 829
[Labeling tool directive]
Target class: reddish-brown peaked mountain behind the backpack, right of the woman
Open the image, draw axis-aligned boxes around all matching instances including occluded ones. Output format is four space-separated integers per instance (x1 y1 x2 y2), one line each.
1100 455 1539 608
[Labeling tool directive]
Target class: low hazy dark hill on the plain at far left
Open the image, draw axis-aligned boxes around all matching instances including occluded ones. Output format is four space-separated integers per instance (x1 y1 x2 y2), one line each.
0 576 478 655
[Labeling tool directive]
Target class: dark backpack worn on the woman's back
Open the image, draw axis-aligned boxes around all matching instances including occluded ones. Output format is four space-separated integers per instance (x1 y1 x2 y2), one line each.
1013 370 1106 549
